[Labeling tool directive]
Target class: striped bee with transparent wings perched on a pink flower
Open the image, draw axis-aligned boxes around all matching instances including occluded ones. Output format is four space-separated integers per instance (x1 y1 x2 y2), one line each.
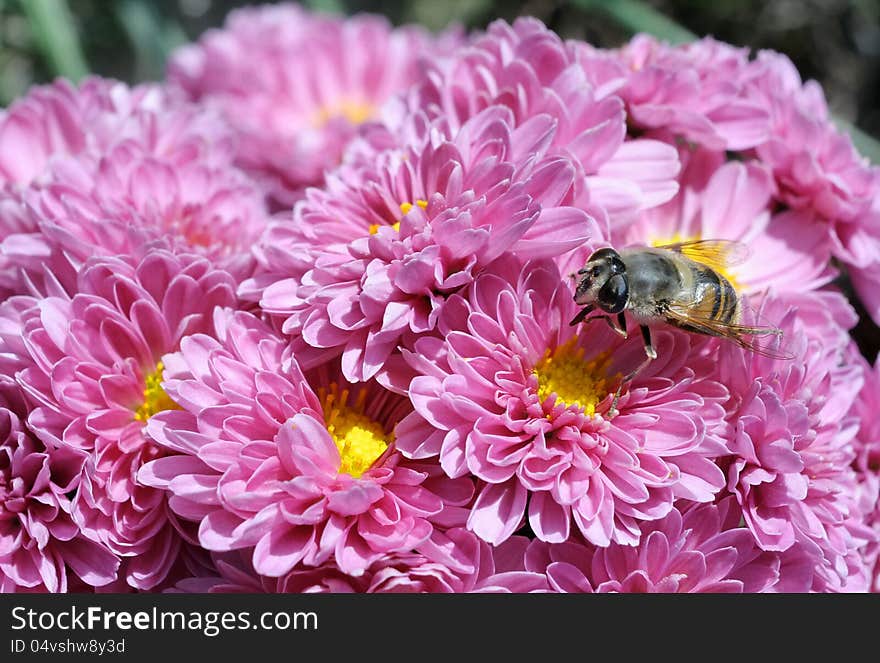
570 240 790 419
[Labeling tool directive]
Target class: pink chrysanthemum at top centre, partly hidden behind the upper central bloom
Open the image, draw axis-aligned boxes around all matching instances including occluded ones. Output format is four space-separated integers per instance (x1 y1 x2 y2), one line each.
408 17 679 222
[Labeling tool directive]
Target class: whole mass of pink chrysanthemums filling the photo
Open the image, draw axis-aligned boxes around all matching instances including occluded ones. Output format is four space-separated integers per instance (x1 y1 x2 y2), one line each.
0 4 880 592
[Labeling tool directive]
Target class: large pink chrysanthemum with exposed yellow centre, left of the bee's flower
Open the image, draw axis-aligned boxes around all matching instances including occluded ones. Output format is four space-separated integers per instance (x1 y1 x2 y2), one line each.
139 311 473 577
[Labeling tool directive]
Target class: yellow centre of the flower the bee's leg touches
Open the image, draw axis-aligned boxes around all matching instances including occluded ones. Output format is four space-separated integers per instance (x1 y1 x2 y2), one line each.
532 337 611 417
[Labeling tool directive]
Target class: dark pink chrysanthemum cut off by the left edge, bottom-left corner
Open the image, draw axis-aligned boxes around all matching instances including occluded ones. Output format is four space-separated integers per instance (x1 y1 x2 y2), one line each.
0 376 119 593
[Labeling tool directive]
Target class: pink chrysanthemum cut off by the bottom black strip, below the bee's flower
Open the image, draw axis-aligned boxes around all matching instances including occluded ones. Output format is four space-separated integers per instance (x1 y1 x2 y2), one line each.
524 498 813 593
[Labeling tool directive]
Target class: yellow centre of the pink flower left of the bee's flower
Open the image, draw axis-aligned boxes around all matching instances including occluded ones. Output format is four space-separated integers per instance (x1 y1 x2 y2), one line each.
318 384 394 479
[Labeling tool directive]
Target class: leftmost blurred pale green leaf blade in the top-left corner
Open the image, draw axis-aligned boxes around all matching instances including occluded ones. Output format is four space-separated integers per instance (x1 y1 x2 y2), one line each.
20 0 89 82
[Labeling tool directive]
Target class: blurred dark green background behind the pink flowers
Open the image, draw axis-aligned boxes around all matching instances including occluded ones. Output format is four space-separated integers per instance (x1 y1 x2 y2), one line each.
0 0 880 359
